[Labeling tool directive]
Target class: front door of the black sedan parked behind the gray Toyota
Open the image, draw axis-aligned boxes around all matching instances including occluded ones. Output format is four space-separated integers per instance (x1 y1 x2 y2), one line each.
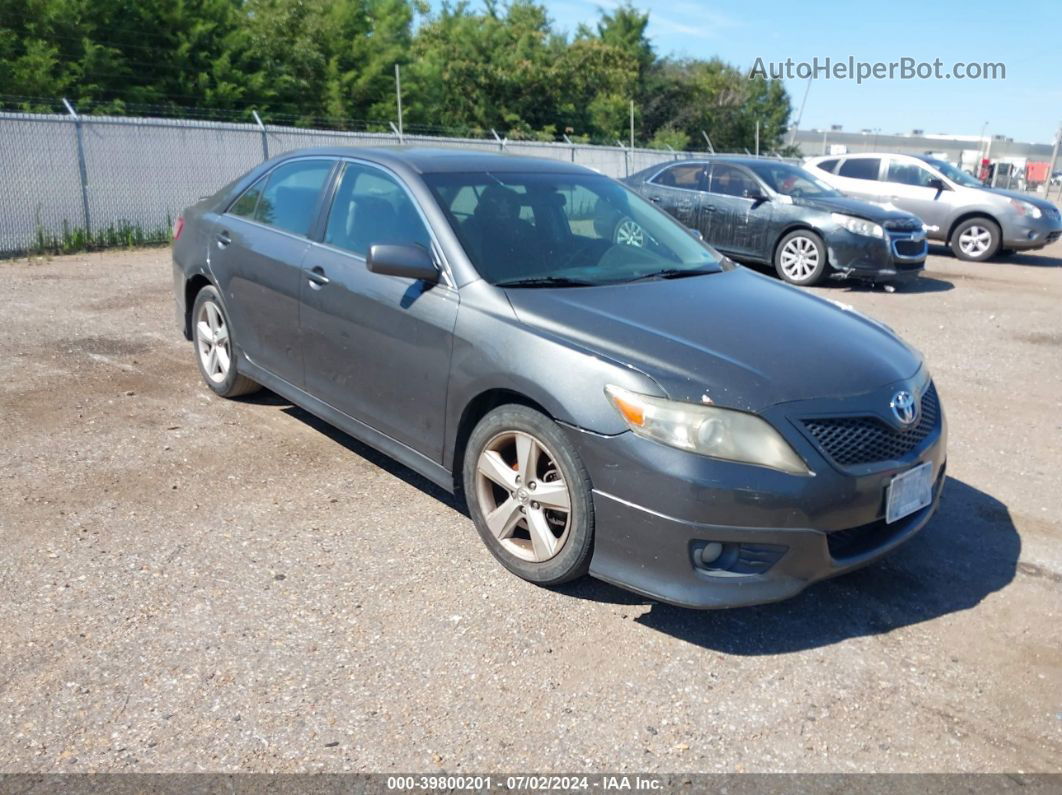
701 162 772 259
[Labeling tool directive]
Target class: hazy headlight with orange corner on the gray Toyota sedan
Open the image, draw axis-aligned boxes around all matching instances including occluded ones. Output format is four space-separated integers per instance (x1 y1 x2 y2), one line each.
604 385 810 474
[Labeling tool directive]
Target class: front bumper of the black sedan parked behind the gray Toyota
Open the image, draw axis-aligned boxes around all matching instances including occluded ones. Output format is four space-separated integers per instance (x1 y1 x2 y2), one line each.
825 228 929 281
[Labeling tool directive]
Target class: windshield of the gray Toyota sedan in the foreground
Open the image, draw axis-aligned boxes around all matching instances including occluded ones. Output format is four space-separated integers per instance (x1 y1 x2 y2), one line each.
424 172 722 287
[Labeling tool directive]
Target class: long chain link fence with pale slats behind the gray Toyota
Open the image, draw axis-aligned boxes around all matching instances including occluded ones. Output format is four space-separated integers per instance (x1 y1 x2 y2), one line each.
0 113 722 256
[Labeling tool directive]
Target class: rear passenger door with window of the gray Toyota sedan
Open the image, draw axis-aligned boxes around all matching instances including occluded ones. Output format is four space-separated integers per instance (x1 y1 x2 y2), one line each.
210 158 336 385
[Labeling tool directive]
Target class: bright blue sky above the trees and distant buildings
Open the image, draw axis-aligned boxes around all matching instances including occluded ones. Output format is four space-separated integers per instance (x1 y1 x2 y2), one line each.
522 0 1062 143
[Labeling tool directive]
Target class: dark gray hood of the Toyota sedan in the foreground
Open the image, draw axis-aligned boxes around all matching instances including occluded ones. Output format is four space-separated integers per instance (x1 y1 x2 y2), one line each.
507 267 922 411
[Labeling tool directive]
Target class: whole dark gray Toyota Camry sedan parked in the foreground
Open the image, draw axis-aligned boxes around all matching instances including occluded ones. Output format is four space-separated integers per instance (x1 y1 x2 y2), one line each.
173 148 946 607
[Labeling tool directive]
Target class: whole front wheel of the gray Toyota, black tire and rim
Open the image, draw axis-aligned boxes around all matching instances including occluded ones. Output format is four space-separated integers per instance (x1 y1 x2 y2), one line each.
462 404 594 586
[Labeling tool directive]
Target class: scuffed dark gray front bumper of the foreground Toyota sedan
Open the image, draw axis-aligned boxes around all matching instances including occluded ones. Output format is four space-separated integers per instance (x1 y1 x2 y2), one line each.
570 375 946 608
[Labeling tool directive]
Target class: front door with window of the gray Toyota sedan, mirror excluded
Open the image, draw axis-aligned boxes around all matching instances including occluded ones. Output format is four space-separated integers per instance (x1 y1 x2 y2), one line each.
302 162 458 462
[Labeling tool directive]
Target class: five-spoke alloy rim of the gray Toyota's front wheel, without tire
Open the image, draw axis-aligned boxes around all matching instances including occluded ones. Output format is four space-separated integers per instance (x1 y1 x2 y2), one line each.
476 431 571 563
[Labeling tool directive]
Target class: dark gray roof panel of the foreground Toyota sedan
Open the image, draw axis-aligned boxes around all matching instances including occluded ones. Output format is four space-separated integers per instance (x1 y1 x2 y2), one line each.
269 145 598 174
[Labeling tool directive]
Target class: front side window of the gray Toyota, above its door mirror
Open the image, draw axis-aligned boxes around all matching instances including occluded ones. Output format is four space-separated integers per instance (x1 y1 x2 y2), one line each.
325 157 431 251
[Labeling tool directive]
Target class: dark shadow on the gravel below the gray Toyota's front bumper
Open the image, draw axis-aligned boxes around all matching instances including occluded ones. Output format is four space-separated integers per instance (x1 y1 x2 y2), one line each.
567 478 1022 655
